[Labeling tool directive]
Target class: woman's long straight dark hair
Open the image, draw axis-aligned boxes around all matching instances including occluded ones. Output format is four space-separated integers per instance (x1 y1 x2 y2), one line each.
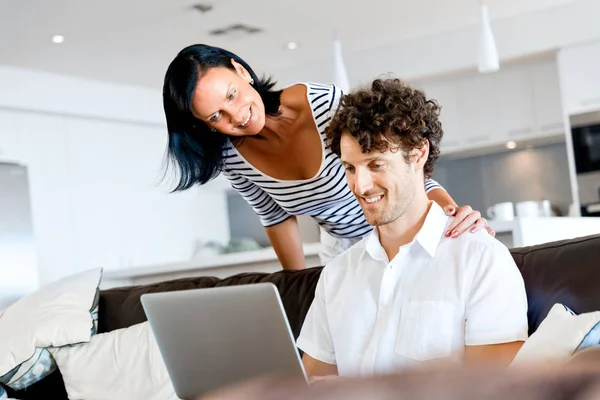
163 44 281 191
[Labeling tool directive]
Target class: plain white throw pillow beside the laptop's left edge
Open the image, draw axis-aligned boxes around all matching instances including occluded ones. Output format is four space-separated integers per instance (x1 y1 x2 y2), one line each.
50 322 178 400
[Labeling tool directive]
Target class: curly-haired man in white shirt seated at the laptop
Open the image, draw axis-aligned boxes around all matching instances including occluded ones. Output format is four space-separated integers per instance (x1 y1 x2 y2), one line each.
297 79 527 376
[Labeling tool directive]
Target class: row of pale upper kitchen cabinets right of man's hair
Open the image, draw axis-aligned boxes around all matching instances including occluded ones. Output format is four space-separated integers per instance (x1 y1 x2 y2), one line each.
421 60 564 154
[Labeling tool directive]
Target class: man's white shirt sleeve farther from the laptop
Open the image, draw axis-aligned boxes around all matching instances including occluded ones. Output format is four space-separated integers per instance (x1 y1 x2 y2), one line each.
465 240 528 346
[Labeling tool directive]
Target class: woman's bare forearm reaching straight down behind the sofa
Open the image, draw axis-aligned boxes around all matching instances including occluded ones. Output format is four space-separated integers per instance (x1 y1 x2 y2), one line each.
265 216 306 270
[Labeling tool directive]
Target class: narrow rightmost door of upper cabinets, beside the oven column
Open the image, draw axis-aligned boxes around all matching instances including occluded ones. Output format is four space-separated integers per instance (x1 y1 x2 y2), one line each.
532 62 565 137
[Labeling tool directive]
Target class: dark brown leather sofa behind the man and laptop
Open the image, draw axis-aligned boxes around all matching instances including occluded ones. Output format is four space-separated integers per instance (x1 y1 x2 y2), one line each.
7 235 600 400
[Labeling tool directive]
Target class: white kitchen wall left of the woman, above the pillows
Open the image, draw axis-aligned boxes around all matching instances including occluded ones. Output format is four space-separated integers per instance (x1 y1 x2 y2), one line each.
0 67 229 284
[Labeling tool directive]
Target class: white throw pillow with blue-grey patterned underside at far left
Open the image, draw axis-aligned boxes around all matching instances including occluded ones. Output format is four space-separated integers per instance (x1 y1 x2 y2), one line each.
0 268 102 390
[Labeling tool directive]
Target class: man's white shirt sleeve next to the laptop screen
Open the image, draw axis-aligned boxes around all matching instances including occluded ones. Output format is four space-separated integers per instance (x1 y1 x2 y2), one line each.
296 267 337 365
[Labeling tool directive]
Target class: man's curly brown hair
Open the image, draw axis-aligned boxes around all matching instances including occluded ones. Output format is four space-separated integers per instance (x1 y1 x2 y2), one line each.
325 78 444 178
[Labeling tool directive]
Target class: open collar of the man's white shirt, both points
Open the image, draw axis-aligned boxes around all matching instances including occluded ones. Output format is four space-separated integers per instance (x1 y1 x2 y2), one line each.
365 201 449 262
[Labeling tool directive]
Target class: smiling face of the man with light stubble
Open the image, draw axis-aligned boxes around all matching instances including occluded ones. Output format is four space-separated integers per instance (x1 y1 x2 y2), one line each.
340 134 427 226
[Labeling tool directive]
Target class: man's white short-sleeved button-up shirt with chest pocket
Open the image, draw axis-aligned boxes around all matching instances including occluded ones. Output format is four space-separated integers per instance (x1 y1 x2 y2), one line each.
297 202 528 376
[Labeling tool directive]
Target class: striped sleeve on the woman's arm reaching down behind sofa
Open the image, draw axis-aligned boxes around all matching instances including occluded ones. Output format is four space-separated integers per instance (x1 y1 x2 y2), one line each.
223 169 290 227
